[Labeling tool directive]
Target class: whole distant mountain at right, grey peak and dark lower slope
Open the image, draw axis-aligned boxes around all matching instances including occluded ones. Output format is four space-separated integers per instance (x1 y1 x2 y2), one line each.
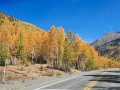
92 32 120 60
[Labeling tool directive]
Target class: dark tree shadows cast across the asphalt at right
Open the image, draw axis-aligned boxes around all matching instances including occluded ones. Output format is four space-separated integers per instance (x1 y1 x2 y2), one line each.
84 71 120 90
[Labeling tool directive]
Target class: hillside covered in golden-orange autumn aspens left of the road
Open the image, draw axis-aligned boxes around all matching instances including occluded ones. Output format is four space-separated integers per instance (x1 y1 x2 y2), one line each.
0 12 120 71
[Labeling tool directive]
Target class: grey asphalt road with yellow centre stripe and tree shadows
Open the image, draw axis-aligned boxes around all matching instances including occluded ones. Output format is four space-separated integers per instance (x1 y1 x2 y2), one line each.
34 69 120 90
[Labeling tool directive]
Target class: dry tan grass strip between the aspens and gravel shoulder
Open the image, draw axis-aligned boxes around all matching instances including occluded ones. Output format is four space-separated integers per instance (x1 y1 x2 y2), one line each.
0 64 78 81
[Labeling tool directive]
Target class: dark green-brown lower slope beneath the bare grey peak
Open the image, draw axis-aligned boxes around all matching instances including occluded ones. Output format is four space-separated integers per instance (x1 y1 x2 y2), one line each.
96 38 120 60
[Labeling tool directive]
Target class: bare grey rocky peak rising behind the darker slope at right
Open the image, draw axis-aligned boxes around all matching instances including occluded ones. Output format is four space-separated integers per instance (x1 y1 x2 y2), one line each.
92 32 120 48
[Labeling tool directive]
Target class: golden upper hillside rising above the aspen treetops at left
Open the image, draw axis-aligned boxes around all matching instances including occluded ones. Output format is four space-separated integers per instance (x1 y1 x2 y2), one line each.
0 12 42 31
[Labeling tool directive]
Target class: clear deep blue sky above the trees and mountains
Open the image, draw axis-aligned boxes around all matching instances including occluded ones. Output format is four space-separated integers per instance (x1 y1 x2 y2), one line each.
0 0 120 43
